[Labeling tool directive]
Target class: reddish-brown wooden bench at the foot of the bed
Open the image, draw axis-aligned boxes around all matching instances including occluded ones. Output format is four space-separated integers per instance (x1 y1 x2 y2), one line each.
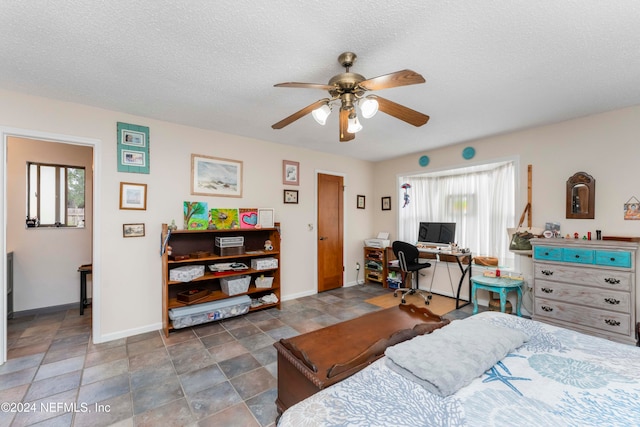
274 304 449 413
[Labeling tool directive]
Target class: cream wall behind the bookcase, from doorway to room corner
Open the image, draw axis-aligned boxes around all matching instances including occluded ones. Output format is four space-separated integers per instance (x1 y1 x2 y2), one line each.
0 91 375 342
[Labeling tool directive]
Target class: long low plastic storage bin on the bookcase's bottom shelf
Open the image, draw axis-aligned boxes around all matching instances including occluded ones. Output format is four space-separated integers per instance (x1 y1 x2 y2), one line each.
169 295 251 329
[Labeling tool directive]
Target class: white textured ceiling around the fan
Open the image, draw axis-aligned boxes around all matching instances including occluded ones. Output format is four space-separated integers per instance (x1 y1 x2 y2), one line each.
0 0 640 161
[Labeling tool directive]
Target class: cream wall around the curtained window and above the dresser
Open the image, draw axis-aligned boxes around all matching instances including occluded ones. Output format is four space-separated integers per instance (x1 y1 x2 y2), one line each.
374 106 640 318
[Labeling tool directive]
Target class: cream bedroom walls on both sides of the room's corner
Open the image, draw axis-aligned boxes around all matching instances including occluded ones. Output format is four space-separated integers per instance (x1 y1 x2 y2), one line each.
0 91 640 341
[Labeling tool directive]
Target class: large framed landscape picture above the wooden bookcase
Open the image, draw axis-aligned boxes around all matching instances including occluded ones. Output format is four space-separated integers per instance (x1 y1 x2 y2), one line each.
191 154 242 197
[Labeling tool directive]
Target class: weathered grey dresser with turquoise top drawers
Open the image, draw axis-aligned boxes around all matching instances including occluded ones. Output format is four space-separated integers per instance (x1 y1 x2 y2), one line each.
531 239 638 344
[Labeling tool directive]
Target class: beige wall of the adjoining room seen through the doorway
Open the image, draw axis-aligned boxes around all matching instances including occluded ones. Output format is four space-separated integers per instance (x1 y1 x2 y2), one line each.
6 137 93 312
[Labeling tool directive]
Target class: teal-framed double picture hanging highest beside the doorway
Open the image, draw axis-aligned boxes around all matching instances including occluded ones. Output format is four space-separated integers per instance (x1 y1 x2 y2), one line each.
117 122 149 173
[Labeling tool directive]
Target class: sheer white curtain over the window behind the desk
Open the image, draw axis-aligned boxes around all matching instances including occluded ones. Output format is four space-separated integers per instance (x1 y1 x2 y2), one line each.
398 161 515 266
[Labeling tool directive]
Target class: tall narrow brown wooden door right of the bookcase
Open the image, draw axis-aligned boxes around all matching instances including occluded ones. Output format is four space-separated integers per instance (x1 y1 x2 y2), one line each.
317 174 344 292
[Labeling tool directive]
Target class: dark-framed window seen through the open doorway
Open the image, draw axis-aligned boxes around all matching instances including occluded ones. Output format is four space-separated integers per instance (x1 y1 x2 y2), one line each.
27 162 85 227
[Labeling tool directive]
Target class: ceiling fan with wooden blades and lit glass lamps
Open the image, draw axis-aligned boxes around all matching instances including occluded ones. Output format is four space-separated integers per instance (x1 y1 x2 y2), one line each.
271 52 429 141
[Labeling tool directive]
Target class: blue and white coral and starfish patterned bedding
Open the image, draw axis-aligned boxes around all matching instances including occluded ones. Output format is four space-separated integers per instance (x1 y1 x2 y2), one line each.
278 312 640 427
